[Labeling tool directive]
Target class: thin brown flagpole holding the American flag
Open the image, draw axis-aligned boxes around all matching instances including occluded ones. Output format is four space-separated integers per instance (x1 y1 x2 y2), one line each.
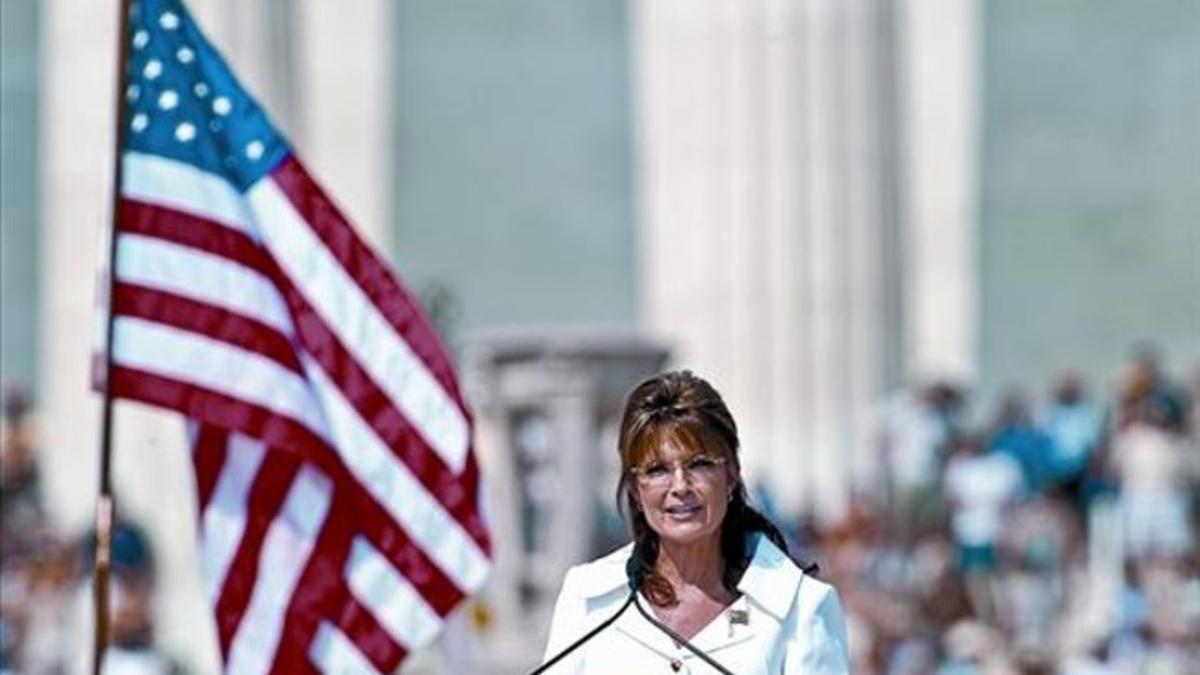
91 0 130 675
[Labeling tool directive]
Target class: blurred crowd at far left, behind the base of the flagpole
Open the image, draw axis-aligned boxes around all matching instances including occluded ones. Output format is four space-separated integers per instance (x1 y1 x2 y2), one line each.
0 389 180 675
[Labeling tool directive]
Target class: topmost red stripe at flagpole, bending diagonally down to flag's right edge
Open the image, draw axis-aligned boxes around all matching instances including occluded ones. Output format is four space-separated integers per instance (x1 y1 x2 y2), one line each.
113 195 491 555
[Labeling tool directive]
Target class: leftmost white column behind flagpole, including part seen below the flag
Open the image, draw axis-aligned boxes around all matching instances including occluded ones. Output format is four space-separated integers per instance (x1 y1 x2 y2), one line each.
38 0 217 671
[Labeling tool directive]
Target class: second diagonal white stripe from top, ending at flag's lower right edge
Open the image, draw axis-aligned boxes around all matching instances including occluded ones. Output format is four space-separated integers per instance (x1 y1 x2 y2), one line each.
302 357 488 592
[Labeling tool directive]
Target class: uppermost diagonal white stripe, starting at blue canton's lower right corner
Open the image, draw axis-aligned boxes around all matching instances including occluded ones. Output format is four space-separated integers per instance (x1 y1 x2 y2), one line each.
246 179 469 472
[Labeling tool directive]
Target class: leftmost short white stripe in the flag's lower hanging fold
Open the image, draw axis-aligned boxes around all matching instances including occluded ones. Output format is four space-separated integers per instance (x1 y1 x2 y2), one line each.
200 434 266 605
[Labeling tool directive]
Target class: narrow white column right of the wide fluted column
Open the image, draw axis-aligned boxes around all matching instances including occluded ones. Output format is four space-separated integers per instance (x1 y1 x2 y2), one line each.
898 0 980 380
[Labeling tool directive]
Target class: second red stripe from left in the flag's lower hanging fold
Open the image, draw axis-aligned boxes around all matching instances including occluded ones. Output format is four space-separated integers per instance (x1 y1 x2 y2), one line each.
214 448 300 658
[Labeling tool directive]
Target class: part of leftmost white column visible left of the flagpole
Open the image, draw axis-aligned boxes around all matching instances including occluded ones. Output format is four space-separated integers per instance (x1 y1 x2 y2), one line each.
38 0 116 530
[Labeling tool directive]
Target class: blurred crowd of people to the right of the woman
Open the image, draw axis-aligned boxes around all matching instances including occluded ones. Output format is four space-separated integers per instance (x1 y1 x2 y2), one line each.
799 348 1200 675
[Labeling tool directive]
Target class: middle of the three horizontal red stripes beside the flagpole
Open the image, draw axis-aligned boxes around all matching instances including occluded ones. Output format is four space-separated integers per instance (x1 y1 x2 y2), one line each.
114 281 304 375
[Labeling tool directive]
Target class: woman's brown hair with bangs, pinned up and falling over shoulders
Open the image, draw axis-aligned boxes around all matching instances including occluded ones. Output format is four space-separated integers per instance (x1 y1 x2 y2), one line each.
617 370 787 607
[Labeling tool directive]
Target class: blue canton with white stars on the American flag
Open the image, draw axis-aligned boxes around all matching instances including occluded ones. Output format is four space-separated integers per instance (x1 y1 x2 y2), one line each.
125 0 290 191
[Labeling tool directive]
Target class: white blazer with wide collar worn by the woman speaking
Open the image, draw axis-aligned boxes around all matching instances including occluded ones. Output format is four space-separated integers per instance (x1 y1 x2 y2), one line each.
542 534 850 675
